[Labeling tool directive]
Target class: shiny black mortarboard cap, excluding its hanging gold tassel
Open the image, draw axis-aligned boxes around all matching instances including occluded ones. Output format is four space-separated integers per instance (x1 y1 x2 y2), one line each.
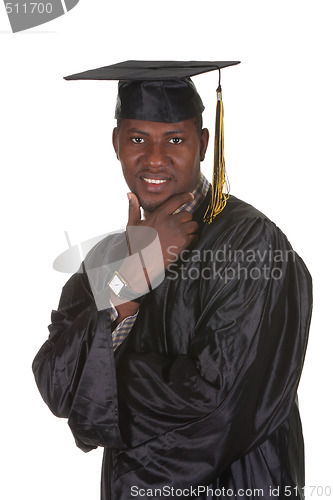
65 61 239 123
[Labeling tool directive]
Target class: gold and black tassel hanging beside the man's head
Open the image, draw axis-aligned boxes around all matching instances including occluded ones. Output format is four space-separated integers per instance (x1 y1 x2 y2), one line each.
203 84 229 224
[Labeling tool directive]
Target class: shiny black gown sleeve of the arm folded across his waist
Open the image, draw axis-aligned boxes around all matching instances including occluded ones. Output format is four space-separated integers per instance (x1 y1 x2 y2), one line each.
114 219 311 500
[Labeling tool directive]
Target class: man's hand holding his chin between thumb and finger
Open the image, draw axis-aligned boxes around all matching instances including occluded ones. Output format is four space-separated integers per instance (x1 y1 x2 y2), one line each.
127 193 199 269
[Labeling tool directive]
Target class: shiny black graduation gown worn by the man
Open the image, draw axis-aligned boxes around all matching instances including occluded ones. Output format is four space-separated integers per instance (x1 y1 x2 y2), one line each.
33 196 312 500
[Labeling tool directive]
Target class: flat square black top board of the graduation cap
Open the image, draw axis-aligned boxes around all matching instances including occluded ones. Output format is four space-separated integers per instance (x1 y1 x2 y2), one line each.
65 61 240 81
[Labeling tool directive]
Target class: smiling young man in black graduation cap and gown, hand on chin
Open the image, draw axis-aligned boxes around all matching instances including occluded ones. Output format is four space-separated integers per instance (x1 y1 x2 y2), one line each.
33 62 311 500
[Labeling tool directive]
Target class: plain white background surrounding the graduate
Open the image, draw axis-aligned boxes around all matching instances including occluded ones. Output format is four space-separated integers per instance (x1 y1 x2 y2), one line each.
0 0 333 500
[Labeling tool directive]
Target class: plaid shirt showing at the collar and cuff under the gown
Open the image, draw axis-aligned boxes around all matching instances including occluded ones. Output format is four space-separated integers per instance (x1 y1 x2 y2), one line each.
111 172 210 350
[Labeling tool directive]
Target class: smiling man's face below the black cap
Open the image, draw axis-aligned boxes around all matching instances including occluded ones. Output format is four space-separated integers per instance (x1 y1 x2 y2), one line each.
113 119 208 212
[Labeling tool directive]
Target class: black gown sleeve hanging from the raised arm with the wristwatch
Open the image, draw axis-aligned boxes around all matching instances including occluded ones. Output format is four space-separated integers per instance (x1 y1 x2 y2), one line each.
32 268 121 452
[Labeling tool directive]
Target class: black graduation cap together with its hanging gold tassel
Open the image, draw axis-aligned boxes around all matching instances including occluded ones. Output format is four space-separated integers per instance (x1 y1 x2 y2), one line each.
65 61 240 223
